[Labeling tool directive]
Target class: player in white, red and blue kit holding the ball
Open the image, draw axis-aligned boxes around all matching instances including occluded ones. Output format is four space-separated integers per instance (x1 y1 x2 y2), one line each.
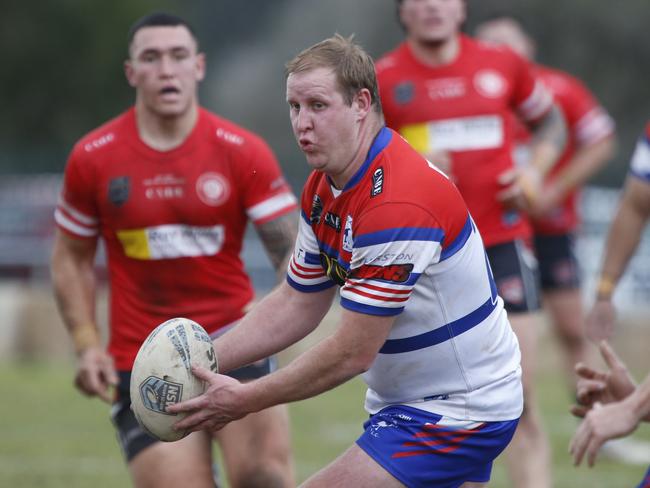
170 36 523 488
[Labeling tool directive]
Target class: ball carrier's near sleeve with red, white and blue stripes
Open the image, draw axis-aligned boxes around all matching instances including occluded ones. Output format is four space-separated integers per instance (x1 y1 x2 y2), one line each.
341 203 444 316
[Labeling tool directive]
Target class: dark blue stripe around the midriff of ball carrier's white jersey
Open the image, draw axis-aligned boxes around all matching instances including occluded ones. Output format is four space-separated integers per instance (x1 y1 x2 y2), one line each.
379 298 498 354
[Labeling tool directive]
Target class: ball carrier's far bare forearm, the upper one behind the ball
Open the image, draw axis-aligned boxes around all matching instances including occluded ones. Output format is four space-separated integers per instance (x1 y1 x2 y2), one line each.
214 281 334 372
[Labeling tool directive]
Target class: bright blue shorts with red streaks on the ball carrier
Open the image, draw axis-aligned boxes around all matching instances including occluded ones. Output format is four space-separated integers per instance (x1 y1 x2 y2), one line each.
357 405 519 488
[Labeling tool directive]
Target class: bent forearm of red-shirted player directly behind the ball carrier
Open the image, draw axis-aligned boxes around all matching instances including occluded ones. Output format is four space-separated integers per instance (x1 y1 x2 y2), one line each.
530 105 568 176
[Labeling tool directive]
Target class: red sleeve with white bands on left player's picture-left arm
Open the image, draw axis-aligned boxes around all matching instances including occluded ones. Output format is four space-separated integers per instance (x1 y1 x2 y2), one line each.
54 147 99 238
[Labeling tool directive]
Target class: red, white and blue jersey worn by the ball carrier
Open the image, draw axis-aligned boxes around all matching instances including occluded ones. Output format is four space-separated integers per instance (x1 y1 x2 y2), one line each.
287 128 522 421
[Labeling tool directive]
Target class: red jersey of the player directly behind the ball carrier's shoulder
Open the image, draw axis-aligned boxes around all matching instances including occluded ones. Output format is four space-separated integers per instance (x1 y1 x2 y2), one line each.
377 36 553 246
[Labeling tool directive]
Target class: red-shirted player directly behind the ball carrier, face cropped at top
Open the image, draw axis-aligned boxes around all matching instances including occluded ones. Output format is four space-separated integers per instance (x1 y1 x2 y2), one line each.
377 0 567 488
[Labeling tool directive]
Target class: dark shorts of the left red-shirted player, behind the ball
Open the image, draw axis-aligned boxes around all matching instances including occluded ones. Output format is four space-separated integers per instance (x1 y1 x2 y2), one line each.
111 357 277 462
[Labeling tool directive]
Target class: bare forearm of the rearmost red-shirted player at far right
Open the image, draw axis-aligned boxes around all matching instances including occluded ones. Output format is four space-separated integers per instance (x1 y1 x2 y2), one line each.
554 136 616 195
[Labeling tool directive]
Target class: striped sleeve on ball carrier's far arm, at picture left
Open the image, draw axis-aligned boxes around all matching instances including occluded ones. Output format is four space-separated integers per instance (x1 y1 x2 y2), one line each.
287 206 335 293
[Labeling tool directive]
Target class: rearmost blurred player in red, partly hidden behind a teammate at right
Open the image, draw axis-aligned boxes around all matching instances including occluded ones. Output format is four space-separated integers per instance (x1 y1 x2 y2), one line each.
476 16 615 383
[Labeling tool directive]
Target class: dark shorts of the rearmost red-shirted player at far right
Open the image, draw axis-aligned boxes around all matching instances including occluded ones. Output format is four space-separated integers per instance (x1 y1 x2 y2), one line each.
535 234 580 291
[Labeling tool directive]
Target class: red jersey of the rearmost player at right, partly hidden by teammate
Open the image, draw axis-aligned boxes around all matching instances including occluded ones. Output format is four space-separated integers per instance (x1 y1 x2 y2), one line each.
515 65 615 235
